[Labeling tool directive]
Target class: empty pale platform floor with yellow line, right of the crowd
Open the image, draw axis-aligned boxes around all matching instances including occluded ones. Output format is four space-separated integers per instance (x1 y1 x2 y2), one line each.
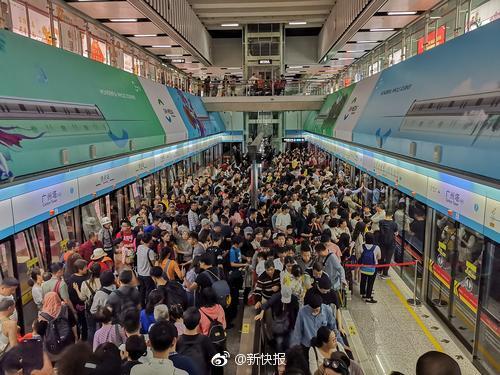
342 270 480 375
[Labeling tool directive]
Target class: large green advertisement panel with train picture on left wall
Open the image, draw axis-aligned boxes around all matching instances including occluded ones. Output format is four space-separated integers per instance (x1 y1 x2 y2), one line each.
0 30 164 180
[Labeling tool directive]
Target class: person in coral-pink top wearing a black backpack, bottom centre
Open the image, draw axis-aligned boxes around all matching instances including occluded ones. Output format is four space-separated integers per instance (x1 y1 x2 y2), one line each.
199 287 226 352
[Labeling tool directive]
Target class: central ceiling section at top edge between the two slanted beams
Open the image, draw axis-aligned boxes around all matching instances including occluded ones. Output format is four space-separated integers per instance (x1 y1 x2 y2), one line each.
188 0 335 30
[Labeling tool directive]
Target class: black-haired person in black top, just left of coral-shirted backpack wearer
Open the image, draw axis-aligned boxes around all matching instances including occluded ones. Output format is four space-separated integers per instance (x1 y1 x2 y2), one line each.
177 307 217 375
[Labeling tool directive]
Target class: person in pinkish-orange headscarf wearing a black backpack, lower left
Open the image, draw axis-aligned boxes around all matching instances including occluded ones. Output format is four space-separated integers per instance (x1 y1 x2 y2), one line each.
39 292 77 362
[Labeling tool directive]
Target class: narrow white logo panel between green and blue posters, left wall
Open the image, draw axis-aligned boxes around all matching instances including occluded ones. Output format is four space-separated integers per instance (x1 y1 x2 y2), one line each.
139 77 188 143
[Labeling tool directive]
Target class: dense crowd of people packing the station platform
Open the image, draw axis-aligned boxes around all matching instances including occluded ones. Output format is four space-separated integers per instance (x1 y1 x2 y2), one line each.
0 149 462 375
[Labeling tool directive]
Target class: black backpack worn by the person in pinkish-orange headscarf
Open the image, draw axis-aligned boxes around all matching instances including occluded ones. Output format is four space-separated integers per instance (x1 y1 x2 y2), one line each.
40 306 75 354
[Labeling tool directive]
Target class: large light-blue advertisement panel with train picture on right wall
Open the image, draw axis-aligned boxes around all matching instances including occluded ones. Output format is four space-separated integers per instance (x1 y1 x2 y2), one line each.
353 21 500 178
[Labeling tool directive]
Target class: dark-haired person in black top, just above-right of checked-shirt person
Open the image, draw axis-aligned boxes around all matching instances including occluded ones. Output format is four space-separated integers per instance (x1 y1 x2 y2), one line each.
107 269 141 323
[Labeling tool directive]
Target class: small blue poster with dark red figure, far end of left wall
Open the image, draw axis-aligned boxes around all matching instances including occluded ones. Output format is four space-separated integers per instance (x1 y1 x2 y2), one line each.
167 87 224 139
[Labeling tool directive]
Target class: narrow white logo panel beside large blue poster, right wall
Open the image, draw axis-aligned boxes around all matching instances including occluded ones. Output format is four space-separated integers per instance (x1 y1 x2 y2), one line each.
335 74 379 141
